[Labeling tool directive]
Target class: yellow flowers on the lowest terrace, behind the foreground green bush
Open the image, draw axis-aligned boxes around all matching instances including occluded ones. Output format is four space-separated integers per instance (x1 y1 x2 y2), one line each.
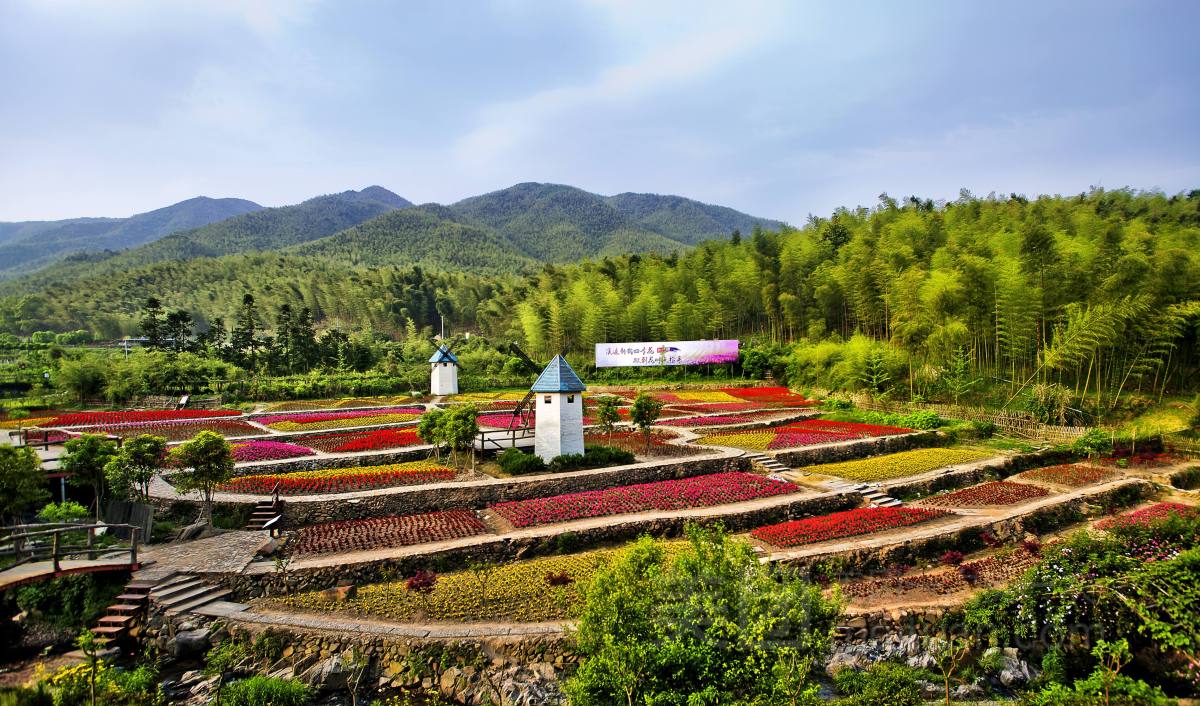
272 542 686 622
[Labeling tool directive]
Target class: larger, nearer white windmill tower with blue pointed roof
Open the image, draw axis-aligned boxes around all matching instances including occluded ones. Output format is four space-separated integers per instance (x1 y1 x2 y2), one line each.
529 355 588 461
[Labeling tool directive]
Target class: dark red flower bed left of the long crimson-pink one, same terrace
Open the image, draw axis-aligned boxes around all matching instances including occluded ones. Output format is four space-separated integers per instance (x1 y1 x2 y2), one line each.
289 510 487 556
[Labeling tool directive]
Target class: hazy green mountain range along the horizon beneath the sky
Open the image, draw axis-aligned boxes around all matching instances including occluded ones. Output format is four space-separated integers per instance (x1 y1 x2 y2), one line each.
0 183 780 280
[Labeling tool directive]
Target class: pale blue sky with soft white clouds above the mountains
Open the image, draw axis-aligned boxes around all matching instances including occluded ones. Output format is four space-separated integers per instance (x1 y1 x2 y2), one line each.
0 0 1200 225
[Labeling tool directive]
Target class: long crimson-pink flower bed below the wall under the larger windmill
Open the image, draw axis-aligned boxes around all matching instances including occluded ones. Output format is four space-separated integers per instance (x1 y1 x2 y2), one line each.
492 473 799 527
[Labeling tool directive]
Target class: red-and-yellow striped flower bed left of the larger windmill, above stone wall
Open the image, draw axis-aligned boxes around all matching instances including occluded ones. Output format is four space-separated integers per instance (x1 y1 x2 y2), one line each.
221 461 455 495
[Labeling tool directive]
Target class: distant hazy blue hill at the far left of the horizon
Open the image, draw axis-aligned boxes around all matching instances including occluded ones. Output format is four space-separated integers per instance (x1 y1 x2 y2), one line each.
0 196 263 277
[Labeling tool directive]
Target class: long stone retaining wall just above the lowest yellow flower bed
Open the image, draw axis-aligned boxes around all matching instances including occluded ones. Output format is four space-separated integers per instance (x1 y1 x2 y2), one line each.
216 492 862 600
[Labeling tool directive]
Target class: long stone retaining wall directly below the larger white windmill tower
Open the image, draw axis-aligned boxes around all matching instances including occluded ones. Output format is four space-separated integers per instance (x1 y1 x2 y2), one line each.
273 455 750 527
